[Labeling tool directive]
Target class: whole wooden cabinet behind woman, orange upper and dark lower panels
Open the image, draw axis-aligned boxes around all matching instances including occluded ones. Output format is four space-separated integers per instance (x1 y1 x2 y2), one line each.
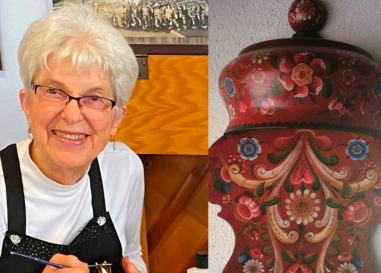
116 56 208 273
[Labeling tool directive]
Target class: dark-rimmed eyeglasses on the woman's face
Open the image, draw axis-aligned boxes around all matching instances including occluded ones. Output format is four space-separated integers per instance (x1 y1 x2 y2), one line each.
32 84 116 119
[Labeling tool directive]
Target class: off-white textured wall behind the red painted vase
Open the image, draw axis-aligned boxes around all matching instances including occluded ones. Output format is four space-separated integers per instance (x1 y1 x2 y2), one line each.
209 0 381 273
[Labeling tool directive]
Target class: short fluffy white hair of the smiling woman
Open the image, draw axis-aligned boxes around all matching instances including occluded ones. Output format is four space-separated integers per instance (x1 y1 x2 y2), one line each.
18 3 138 113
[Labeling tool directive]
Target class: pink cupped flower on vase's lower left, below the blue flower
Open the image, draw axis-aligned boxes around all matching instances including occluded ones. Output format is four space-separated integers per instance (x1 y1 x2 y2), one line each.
234 195 262 222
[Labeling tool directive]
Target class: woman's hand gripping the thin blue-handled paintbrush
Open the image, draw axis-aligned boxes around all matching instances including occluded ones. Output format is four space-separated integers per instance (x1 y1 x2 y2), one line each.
42 254 88 273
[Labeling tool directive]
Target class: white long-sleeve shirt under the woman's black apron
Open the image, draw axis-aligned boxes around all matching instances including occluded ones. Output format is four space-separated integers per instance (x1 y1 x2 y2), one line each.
0 140 147 272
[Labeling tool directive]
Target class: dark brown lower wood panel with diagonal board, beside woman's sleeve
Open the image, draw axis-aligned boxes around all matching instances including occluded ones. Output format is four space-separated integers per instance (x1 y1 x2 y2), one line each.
140 155 208 273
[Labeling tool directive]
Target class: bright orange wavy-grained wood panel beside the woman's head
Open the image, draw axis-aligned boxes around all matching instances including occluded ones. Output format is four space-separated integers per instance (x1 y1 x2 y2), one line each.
116 56 208 155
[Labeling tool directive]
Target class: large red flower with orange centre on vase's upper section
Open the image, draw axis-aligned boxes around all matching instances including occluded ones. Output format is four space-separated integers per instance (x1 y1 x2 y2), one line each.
279 52 326 98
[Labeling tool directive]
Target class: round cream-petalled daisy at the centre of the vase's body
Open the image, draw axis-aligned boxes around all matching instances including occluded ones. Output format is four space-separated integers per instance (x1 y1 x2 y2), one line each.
285 190 320 226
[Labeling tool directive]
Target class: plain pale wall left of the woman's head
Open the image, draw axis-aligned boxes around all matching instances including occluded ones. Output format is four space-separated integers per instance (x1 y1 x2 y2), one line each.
0 0 53 149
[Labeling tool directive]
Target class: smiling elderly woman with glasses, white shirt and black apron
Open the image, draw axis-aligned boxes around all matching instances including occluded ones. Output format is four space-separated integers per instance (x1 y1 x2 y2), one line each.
0 5 146 273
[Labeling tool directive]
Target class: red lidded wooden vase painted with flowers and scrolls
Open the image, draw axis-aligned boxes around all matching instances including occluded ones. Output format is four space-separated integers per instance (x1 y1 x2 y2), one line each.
209 0 381 273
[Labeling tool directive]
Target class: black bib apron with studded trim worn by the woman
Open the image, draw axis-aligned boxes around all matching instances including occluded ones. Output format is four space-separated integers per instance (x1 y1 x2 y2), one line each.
0 144 124 273
